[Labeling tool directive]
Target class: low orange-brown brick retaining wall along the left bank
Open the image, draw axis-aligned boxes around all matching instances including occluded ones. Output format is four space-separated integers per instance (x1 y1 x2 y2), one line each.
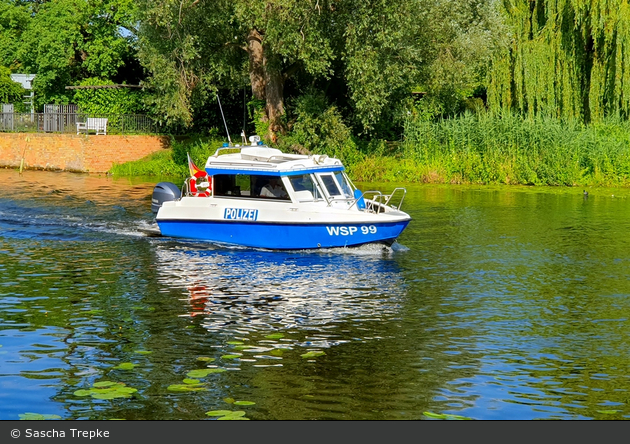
0 133 170 173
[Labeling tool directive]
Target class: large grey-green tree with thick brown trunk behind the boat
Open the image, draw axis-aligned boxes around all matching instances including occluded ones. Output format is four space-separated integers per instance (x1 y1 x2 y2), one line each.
140 0 430 140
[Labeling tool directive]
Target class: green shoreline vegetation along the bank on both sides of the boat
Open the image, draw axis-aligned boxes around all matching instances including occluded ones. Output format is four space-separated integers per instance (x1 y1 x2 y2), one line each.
110 112 630 187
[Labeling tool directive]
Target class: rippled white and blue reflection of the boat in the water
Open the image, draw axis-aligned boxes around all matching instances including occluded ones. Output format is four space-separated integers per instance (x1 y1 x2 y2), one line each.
156 244 405 342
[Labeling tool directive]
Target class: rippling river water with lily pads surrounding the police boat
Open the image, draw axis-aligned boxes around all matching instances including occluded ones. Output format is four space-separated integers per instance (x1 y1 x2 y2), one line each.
0 170 630 420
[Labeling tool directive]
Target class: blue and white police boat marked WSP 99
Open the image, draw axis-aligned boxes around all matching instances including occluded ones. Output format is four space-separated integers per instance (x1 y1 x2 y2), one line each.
151 136 411 250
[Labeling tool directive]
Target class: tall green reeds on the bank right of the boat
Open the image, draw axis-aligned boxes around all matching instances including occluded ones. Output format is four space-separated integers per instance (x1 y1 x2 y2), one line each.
351 114 630 186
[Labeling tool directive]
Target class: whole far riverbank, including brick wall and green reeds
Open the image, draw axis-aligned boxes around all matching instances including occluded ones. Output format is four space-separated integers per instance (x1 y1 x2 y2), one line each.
0 113 630 187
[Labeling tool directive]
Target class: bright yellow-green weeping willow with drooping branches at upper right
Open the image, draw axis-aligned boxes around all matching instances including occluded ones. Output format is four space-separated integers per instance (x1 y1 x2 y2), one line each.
488 0 630 122
